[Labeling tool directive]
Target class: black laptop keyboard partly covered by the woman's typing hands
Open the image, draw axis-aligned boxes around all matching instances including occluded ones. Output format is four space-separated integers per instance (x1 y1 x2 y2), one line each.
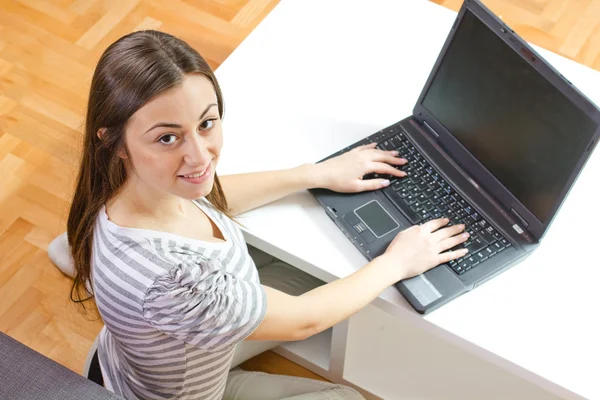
363 132 511 275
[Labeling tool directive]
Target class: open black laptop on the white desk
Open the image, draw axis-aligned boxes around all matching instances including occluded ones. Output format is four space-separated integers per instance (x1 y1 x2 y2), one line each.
311 0 600 313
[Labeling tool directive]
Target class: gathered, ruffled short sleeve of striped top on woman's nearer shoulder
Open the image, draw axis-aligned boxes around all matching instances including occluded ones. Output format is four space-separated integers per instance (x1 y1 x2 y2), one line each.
143 260 267 351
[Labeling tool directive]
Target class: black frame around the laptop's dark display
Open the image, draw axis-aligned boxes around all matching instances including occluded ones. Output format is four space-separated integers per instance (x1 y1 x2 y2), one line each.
413 0 600 240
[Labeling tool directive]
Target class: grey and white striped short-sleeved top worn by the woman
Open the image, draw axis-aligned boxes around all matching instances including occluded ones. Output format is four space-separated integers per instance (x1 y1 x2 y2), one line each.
91 199 267 399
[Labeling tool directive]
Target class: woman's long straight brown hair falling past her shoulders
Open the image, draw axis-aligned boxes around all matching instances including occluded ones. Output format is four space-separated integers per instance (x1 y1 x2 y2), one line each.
67 30 231 311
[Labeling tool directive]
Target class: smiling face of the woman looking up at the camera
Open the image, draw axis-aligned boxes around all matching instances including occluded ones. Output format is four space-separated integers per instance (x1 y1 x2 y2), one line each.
125 74 223 200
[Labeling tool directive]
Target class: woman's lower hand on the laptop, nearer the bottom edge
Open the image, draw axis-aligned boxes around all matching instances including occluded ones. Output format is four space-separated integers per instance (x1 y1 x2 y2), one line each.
378 218 469 284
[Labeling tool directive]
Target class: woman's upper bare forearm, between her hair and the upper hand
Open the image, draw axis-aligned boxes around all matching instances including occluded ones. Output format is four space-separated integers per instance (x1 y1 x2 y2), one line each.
219 164 317 215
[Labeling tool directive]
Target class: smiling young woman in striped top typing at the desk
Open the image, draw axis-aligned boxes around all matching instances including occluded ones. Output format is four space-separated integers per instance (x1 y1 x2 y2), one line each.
50 31 467 400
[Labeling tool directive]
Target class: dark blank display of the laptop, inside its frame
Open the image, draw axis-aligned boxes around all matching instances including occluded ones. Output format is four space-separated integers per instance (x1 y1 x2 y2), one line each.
423 10 597 223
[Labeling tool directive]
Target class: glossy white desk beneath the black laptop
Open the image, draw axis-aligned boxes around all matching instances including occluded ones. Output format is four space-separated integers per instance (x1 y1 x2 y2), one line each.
217 0 600 398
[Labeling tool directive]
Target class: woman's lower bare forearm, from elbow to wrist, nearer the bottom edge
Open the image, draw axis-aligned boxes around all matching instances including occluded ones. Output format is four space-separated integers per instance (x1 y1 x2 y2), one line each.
298 258 394 336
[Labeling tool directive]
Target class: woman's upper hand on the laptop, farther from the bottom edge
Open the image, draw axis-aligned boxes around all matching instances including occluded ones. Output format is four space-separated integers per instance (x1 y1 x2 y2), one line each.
315 143 407 193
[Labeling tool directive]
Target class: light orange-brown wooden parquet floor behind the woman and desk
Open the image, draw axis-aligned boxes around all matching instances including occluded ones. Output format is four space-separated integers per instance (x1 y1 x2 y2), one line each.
0 0 600 382
